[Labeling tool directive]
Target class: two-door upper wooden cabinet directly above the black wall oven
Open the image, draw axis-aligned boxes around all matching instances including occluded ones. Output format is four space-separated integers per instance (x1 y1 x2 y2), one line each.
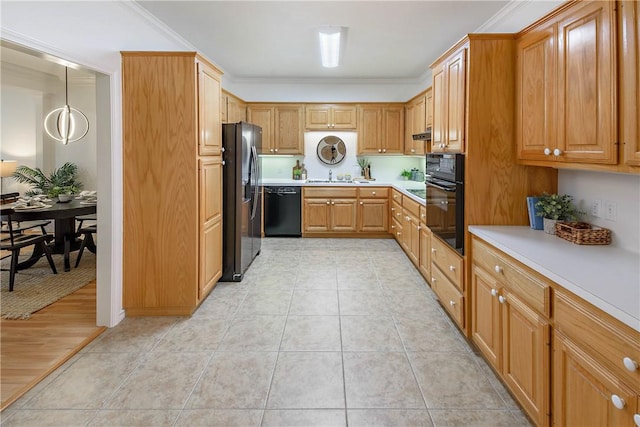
431 44 468 152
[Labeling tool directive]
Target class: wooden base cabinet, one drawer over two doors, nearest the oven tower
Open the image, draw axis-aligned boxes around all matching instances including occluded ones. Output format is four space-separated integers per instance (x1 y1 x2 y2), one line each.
470 238 551 426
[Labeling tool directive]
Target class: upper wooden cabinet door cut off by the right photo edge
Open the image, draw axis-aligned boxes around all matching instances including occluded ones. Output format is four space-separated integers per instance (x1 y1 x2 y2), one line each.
619 1 640 172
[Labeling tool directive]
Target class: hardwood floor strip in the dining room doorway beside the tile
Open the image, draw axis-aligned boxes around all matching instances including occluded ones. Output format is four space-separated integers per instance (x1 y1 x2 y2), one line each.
0 281 106 410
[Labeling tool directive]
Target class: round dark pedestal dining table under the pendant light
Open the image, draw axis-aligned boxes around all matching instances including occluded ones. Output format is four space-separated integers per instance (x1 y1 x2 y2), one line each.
11 199 97 271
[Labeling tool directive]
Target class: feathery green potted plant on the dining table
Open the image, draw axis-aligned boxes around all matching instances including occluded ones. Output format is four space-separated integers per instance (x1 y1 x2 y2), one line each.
13 162 82 201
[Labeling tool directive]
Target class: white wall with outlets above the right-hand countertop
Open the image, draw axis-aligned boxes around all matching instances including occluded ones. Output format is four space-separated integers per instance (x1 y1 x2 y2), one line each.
558 170 640 254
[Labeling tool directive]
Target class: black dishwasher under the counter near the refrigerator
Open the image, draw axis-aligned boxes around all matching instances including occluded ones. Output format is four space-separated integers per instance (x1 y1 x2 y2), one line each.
264 186 302 237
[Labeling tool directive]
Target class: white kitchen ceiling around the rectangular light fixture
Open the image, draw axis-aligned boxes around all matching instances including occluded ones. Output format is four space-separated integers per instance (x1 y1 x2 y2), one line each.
138 1 516 82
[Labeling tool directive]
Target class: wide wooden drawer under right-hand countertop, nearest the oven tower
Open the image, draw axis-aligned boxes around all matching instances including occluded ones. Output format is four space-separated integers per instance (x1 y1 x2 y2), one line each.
471 238 551 317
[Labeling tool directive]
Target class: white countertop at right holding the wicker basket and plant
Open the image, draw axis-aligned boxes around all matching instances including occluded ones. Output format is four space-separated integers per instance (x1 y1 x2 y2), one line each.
469 225 640 332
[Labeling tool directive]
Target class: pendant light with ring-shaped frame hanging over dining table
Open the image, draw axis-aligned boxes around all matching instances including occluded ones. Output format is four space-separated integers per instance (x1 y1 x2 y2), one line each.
44 67 89 145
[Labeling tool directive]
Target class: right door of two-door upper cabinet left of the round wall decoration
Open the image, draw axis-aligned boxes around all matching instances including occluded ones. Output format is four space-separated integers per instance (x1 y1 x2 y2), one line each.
274 105 304 154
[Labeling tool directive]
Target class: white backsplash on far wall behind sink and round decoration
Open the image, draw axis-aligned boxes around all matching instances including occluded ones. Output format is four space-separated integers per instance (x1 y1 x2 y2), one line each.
261 132 425 182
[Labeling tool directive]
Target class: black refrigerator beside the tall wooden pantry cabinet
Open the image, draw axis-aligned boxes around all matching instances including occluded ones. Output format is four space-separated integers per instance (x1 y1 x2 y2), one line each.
220 122 262 282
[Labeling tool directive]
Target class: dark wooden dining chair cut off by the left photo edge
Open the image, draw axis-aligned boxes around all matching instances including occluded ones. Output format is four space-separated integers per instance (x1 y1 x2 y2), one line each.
0 207 58 292
